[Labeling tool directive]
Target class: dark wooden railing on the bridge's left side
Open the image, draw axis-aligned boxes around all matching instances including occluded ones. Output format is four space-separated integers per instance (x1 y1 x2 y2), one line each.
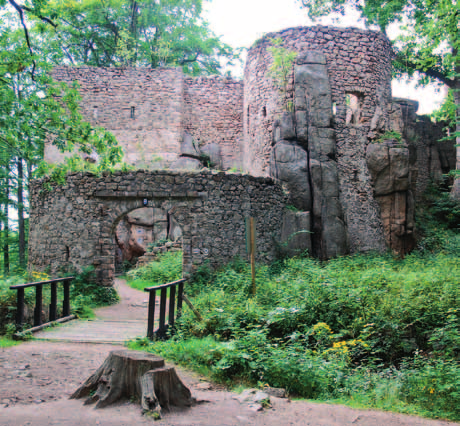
10 277 74 331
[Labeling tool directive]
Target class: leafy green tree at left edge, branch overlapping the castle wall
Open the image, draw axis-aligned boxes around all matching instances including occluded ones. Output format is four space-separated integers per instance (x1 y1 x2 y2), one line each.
0 22 122 273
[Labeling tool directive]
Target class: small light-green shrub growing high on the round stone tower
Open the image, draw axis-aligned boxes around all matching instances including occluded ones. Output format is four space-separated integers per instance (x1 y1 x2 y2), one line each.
267 38 297 112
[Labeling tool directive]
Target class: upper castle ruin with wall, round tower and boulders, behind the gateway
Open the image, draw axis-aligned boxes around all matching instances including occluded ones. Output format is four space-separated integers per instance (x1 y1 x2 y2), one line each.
40 26 455 264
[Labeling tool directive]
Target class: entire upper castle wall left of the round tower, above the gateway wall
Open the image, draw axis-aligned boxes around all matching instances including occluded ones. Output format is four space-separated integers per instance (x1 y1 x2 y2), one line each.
49 67 243 170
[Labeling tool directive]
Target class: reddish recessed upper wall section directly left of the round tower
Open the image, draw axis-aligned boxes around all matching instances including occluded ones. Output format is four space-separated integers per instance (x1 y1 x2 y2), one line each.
184 76 244 170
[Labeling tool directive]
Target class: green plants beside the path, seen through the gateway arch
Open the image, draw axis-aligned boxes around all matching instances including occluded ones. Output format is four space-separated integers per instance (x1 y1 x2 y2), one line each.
126 251 182 290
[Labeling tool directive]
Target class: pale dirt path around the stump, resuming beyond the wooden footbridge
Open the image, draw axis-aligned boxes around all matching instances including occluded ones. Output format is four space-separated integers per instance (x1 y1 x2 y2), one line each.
0 280 456 426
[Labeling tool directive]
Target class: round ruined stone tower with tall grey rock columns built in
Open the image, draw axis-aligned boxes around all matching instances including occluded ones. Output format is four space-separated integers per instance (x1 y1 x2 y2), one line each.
243 26 391 257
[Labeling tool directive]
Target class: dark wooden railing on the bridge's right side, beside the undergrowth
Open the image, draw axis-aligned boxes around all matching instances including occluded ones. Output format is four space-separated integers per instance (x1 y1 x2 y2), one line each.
144 278 187 339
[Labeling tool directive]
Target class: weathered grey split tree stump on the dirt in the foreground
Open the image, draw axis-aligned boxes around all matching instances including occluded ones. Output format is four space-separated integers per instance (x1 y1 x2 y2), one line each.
70 350 193 415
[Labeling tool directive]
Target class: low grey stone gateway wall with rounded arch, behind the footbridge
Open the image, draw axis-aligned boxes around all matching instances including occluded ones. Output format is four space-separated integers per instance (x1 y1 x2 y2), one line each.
29 170 286 285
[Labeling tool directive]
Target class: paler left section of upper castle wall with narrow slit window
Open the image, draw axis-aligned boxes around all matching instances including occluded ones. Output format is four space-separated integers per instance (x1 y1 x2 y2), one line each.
49 67 184 169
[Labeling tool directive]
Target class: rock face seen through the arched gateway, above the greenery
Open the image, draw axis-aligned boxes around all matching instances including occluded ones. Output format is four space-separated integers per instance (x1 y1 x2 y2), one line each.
114 207 182 273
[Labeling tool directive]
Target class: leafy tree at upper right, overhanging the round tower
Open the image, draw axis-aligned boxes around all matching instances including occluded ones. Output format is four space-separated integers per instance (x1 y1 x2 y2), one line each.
300 0 460 198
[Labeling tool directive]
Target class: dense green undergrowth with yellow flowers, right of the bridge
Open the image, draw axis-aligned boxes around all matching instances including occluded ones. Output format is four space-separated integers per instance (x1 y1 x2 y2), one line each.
131 230 460 420
